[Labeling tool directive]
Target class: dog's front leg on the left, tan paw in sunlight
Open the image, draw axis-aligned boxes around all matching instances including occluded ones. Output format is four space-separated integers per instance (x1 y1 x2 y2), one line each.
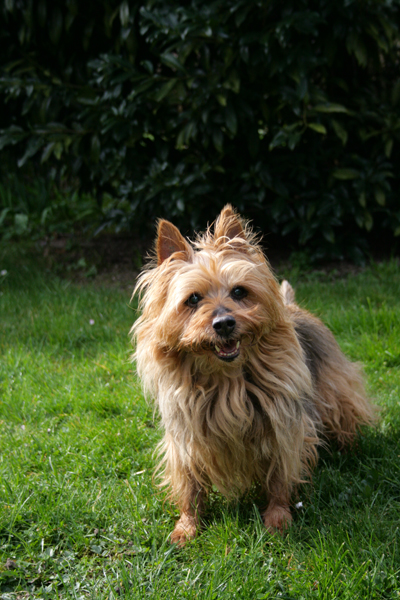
171 480 204 547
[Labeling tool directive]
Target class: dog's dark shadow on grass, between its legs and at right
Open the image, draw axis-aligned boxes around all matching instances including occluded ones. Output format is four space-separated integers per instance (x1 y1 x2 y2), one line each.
192 427 400 544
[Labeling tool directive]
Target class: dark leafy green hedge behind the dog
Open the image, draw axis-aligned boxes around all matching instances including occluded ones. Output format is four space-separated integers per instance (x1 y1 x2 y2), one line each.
0 0 400 259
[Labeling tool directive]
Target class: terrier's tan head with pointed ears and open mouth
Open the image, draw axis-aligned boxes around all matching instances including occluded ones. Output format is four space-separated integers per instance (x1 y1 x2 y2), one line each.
134 205 283 371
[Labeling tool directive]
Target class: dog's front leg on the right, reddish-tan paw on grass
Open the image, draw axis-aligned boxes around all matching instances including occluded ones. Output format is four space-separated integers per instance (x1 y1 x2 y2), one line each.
261 475 292 533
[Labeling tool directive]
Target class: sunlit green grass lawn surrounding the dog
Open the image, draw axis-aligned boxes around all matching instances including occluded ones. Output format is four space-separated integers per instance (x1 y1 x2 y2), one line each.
0 250 400 600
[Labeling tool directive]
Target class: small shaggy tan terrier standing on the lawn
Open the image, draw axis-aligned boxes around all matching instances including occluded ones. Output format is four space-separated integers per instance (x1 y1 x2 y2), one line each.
131 205 374 546
